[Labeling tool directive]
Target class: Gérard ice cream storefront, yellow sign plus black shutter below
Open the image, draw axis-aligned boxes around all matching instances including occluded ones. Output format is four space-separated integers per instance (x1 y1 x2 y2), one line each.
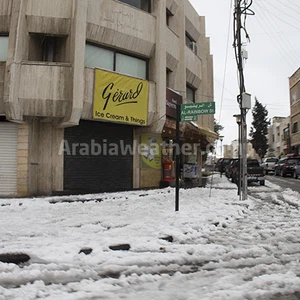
64 69 149 193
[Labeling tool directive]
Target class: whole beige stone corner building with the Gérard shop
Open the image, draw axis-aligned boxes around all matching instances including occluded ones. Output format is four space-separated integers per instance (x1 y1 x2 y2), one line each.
0 0 216 196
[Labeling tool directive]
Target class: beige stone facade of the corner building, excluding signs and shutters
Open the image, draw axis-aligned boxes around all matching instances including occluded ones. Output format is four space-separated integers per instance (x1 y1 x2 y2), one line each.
0 0 215 196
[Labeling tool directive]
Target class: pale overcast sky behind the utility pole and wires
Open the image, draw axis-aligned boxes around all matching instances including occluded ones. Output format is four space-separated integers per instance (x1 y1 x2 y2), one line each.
190 0 300 153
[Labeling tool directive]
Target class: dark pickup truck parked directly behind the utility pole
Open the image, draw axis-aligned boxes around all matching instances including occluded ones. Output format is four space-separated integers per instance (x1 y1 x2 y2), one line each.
232 158 265 185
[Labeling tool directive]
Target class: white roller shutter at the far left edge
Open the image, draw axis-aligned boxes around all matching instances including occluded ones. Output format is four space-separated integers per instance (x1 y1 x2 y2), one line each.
0 122 18 196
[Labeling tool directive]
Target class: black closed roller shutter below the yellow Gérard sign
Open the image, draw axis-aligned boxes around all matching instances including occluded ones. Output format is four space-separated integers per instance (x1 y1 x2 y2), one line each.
64 121 133 193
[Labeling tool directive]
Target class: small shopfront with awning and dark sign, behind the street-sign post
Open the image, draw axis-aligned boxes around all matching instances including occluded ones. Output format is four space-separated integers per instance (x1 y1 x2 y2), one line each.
160 88 217 186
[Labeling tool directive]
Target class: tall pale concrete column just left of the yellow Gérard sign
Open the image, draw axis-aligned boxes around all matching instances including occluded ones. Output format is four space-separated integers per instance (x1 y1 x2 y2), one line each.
59 0 88 128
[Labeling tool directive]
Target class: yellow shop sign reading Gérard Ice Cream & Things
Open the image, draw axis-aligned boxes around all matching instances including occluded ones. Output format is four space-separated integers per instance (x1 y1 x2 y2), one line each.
93 69 148 126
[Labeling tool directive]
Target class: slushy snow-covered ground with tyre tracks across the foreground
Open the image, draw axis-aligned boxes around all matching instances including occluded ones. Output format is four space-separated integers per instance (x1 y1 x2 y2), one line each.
0 176 300 300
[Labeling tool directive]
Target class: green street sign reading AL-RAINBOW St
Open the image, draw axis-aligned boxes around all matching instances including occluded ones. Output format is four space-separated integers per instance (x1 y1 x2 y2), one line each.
180 102 216 120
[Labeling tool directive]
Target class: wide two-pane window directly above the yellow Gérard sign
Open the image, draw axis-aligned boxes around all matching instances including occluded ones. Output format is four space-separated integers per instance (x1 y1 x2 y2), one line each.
85 44 147 79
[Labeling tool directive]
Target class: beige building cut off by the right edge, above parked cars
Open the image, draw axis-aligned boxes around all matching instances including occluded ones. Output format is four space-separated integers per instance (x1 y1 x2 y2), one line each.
289 68 300 155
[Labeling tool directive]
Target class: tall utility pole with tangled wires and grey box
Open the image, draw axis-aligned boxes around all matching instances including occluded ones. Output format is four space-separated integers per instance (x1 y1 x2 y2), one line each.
234 0 254 200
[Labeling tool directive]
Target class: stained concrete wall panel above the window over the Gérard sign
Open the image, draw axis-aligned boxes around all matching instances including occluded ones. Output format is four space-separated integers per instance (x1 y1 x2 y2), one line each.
86 0 154 57
